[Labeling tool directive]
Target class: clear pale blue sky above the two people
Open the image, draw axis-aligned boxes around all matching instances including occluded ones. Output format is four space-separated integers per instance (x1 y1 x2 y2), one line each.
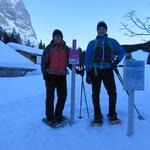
24 0 150 49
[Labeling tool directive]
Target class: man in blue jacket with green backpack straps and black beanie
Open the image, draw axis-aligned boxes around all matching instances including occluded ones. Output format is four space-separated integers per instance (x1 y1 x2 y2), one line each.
85 21 125 125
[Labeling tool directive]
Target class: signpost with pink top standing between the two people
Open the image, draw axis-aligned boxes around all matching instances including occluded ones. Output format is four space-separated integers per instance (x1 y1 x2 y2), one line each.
69 40 79 125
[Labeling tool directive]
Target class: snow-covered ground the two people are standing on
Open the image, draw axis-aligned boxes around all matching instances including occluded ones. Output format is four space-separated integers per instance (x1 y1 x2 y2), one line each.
0 66 150 150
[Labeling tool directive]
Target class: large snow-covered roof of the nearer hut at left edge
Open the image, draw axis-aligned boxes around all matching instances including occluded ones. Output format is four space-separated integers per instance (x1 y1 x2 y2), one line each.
0 41 36 69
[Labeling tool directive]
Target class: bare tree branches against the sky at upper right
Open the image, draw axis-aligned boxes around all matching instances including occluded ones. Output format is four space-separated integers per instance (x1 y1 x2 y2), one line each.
121 10 150 37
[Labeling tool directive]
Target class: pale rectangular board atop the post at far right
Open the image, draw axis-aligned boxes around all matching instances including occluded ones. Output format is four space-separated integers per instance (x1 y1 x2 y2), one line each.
123 59 144 91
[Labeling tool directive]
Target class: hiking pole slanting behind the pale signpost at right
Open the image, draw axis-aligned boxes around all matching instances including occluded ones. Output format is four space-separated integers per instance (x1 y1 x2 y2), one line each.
113 66 144 120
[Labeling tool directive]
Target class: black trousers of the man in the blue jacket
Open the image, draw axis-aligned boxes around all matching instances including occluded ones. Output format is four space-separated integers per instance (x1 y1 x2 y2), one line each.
91 69 117 117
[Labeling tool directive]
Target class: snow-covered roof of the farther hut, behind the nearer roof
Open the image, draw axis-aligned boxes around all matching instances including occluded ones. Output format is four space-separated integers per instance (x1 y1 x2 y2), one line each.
7 42 43 55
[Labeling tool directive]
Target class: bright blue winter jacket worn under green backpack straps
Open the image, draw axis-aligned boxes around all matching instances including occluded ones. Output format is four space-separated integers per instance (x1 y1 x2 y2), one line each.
85 35 125 71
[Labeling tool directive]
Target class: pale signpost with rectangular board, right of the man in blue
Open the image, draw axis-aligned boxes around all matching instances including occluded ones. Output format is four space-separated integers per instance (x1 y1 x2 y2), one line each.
123 59 144 136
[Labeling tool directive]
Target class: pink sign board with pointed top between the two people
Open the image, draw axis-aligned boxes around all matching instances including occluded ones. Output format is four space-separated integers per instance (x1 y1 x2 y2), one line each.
69 40 79 64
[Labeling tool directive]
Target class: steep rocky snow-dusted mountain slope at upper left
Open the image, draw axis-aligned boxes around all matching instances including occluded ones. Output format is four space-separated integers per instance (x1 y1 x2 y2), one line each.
0 0 37 43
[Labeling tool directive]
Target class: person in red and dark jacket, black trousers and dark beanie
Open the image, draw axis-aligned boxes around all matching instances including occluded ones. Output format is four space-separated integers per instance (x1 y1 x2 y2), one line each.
41 29 69 124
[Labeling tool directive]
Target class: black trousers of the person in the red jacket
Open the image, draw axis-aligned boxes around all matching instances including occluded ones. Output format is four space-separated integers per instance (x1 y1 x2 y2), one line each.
45 74 67 120
